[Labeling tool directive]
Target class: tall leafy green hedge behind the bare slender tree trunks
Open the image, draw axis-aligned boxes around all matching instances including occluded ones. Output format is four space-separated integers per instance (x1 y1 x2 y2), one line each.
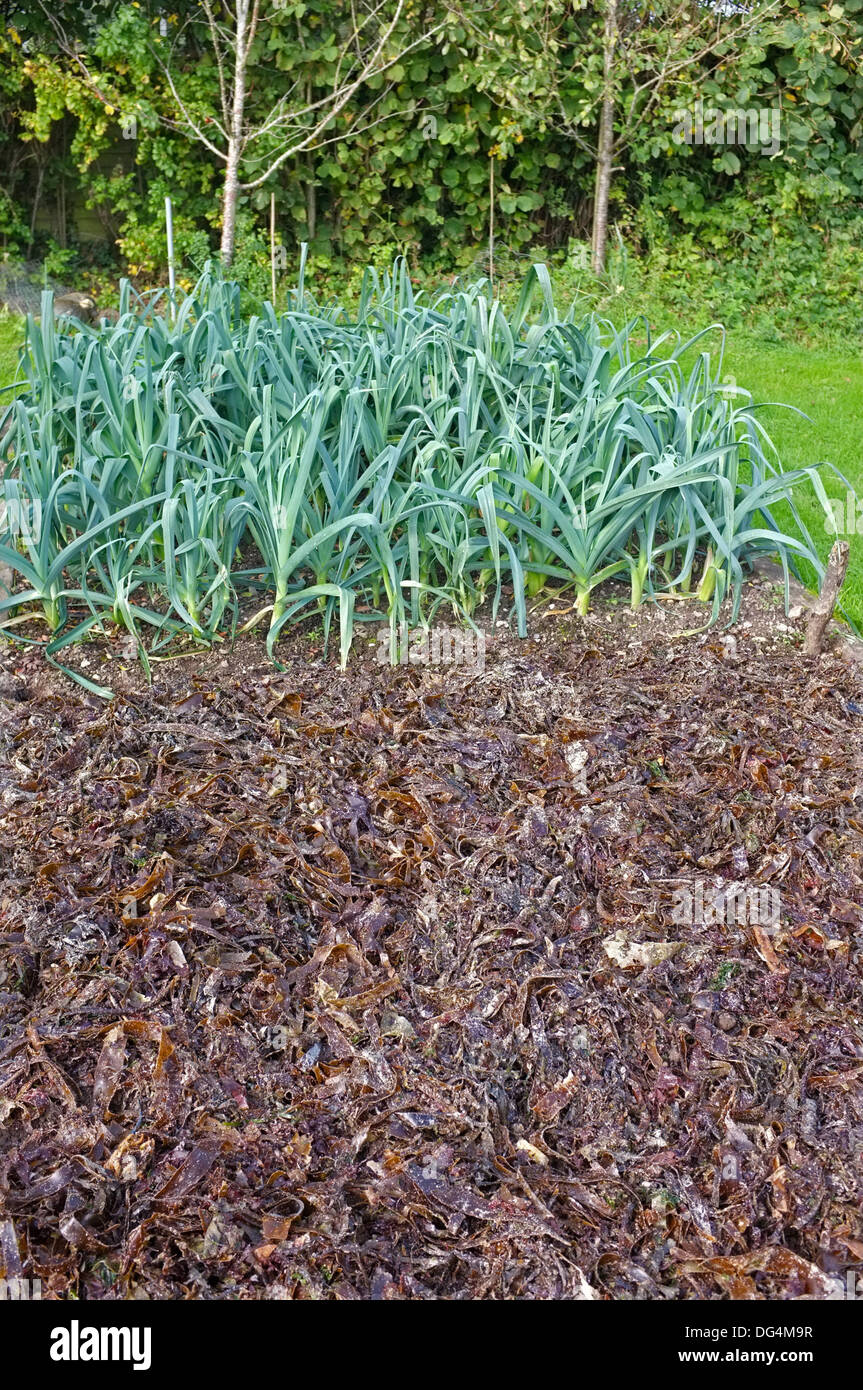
0 0 863 296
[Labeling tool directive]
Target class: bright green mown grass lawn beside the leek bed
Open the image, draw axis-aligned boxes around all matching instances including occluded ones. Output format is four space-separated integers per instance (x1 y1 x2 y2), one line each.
0 314 863 628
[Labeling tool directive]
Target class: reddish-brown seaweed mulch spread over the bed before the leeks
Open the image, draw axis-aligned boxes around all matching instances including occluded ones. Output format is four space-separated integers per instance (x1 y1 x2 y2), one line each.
0 592 863 1300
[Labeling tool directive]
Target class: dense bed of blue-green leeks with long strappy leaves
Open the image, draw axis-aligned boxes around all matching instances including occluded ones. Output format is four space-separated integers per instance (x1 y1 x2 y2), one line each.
0 259 830 689
